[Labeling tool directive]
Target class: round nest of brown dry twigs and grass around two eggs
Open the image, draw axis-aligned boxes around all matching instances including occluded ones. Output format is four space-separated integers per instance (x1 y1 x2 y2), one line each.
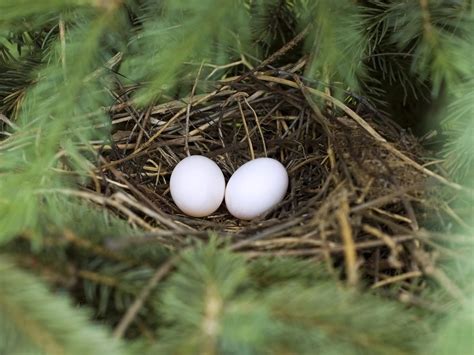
94 65 443 286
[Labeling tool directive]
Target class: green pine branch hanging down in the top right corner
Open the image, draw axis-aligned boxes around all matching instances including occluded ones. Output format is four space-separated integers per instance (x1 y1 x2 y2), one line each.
386 0 473 96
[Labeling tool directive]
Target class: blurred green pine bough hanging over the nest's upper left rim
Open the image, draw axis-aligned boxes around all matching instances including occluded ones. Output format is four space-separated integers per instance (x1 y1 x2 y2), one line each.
121 0 249 103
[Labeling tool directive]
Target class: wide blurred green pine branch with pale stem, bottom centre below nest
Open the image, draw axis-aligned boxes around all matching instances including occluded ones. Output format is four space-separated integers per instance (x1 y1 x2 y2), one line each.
156 244 427 354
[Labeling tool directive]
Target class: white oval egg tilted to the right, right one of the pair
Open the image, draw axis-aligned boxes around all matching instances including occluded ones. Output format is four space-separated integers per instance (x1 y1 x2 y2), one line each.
225 158 288 220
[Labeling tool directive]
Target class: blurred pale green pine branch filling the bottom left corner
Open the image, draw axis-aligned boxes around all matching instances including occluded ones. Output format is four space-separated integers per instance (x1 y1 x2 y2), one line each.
0 256 126 355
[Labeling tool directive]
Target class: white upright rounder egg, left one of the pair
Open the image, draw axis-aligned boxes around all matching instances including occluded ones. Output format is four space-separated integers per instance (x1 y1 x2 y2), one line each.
170 155 225 217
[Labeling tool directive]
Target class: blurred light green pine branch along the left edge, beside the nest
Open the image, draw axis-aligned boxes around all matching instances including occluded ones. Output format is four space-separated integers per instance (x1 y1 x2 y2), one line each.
0 7 124 240
